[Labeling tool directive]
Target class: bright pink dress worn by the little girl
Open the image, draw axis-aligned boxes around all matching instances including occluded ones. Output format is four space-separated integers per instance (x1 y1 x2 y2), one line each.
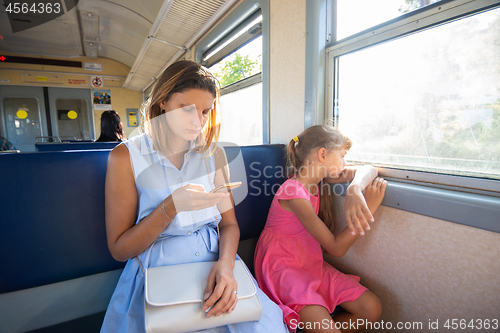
254 179 367 331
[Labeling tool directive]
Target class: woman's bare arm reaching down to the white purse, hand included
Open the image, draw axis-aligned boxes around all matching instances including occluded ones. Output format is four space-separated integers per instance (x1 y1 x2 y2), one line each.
202 147 240 318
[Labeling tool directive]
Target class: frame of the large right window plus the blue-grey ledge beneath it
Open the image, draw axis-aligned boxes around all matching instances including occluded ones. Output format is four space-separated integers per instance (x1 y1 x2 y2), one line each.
325 0 500 233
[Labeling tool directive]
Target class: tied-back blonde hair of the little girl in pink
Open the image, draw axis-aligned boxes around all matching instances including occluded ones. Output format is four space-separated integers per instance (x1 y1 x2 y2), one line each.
287 125 352 232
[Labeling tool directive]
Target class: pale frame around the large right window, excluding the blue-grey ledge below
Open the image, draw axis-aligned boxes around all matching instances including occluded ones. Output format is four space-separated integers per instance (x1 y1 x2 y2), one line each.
325 0 500 192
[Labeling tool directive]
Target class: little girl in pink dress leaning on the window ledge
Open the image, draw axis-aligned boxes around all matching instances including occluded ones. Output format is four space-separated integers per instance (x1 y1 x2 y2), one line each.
255 125 387 332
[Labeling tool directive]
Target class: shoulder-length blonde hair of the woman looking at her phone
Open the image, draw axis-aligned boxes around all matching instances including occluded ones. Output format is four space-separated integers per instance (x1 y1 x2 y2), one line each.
142 60 220 154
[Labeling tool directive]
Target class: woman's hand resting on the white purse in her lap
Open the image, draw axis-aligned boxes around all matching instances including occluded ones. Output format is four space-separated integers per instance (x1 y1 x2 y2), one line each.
202 260 238 318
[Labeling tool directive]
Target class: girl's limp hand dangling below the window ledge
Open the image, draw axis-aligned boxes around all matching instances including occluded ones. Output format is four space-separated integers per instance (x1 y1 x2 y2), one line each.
344 184 374 236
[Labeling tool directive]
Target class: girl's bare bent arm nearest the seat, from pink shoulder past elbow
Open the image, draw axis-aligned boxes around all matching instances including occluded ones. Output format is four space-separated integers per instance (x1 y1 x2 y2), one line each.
279 199 359 257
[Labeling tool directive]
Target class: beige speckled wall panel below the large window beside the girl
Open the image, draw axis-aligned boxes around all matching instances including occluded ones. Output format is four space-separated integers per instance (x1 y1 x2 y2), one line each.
325 196 500 332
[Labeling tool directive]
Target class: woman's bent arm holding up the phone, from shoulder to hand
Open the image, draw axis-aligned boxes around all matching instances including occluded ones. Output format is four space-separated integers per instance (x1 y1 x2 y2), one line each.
105 144 225 261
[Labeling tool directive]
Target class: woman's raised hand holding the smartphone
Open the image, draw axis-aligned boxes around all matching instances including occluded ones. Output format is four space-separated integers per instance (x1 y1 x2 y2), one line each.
172 184 229 213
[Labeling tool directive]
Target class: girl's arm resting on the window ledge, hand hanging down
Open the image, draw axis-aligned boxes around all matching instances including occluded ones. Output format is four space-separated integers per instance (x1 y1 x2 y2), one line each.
325 165 377 236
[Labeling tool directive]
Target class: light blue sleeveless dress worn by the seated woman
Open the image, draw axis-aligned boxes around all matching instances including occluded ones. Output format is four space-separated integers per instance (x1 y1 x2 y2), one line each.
101 134 288 333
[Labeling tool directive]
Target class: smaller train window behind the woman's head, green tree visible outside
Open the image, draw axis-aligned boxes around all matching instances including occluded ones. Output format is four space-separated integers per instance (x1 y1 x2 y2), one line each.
196 0 269 146
